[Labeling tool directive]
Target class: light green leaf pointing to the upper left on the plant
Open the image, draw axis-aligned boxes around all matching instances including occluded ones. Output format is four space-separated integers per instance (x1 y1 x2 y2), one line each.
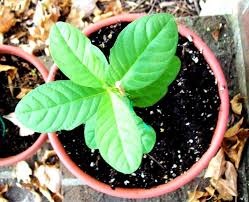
49 22 108 88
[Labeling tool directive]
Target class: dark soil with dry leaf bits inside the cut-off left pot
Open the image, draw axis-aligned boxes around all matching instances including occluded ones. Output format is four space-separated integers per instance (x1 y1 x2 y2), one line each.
0 54 44 158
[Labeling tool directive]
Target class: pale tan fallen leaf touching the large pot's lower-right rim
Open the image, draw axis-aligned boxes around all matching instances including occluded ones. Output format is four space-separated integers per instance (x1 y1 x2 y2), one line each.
204 148 226 180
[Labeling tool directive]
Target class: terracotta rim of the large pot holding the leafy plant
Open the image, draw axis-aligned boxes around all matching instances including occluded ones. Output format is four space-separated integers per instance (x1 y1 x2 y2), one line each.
48 14 229 198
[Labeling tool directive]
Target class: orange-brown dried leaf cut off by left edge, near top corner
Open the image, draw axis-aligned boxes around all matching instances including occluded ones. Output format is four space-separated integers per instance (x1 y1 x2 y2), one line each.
0 4 16 33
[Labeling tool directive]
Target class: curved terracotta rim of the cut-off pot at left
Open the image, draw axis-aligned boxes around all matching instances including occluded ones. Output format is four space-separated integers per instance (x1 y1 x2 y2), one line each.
0 45 48 166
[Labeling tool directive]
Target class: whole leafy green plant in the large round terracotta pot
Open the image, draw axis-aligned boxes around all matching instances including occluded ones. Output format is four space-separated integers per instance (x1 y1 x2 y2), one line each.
16 14 229 198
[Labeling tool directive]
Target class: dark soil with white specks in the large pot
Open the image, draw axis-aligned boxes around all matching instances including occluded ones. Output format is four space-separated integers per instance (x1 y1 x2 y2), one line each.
58 24 220 188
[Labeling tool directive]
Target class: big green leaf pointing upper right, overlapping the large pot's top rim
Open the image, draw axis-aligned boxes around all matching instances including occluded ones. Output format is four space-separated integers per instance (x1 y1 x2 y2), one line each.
106 13 178 92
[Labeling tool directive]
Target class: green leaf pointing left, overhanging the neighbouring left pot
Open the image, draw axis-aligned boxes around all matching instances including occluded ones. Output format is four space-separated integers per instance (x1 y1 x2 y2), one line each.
15 80 105 132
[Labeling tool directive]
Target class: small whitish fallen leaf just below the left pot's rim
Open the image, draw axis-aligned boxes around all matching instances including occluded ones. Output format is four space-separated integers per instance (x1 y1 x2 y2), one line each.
14 161 32 183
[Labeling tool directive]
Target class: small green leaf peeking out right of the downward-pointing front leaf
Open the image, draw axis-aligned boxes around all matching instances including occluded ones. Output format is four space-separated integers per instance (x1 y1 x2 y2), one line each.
136 116 156 154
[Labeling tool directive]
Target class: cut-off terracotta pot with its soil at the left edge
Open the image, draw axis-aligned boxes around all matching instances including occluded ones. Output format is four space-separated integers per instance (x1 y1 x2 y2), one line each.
0 45 48 166
